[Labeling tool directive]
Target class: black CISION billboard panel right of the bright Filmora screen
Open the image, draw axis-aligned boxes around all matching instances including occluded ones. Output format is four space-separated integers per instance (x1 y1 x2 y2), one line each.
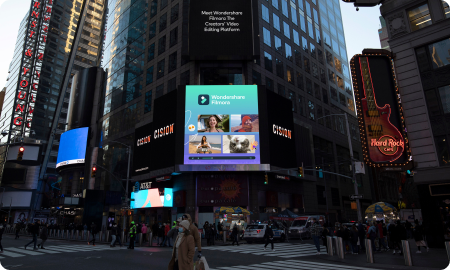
258 87 297 168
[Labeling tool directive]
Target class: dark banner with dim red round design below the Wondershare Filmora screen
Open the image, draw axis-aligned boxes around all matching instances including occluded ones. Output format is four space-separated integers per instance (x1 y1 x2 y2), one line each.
197 174 248 206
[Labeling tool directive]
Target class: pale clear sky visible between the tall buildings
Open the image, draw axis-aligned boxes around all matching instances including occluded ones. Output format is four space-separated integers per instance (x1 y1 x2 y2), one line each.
0 0 381 89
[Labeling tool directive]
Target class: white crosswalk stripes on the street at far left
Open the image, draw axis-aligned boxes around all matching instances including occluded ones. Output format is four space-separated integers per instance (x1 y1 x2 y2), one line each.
0 245 120 259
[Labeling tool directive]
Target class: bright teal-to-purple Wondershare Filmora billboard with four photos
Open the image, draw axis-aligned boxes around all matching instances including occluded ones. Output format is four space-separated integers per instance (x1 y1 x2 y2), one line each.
184 85 260 164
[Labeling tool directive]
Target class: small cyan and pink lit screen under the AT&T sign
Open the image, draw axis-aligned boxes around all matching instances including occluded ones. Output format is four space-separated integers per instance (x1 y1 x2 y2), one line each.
130 188 173 209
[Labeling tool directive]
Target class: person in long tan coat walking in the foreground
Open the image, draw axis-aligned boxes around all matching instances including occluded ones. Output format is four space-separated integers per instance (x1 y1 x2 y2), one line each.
168 220 198 270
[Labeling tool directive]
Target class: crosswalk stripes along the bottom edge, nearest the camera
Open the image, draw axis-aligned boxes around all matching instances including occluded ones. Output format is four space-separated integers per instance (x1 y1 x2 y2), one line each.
210 260 380 270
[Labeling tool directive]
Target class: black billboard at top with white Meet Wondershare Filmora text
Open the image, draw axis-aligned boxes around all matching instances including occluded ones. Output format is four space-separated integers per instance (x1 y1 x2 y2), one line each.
188 0 258 60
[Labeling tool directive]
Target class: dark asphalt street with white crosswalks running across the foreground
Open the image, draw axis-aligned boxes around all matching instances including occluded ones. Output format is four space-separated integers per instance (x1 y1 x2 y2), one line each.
0 235 448 270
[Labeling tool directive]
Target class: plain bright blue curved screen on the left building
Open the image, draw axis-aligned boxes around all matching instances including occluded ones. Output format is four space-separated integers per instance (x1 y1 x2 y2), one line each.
56 127 89 168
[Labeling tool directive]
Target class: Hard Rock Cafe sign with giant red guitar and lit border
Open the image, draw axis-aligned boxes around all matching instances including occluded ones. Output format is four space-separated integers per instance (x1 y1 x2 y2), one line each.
351 54 410 167
